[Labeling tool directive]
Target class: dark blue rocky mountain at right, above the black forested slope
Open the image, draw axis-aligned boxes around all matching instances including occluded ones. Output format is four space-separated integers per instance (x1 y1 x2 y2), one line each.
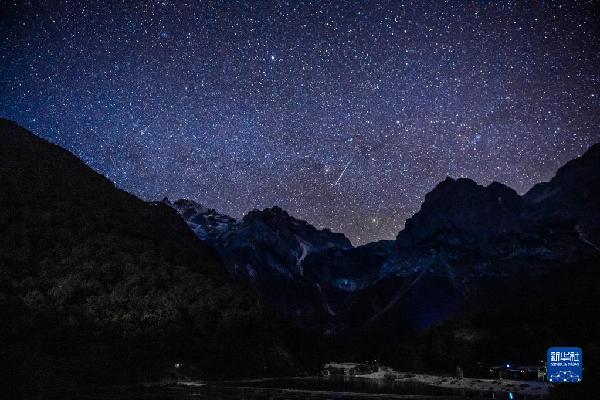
360 145 600 326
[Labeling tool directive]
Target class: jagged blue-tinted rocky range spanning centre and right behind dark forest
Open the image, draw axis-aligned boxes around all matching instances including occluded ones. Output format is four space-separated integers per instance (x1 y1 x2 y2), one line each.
170 144 600 332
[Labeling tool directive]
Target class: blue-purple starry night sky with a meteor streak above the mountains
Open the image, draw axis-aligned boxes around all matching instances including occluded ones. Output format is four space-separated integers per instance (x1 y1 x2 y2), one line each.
0 0 600 244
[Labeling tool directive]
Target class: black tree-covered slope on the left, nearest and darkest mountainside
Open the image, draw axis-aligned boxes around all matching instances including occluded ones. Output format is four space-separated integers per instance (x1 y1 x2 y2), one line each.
0 120 302 395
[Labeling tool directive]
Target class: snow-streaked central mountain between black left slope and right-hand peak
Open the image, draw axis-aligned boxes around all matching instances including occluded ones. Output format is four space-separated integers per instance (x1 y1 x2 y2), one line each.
169 199 352 332
